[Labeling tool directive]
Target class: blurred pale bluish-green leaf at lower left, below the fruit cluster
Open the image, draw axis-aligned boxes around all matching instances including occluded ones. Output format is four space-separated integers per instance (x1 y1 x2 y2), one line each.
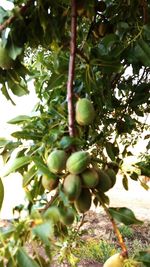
32 221 54 246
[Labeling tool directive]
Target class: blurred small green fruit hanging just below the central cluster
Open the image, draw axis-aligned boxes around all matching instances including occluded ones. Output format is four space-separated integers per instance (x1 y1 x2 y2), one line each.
60 208 75 225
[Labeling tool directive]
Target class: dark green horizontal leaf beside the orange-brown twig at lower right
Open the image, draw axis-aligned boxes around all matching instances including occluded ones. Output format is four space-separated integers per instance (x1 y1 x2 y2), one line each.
108 207 143 225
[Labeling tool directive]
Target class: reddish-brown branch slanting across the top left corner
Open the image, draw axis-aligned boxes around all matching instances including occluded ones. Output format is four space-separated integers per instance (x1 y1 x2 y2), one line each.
0 0 33 32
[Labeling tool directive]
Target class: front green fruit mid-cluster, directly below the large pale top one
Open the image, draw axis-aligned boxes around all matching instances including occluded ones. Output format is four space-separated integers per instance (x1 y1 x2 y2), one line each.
63 174 81 201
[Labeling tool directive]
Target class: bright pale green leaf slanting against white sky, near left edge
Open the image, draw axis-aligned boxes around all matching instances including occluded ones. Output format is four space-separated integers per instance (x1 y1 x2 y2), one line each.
2 156 31 176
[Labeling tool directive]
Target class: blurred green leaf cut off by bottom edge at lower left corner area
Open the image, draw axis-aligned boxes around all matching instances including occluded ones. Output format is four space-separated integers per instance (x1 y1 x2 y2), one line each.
16 247 40 267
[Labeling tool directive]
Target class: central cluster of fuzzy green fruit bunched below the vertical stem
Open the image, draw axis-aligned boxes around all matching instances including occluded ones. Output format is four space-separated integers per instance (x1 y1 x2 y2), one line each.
42 150 116 213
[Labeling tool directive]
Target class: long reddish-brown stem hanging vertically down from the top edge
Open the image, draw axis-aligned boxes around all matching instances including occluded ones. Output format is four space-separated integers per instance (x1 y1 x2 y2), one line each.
67 0 77 136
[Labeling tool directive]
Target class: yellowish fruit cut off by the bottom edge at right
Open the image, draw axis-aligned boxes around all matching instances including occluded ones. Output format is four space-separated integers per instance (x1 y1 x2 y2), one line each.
103 253 124 267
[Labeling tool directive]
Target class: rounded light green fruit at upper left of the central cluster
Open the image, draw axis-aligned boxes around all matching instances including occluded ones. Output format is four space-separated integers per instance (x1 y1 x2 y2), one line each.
47 150 67 173
